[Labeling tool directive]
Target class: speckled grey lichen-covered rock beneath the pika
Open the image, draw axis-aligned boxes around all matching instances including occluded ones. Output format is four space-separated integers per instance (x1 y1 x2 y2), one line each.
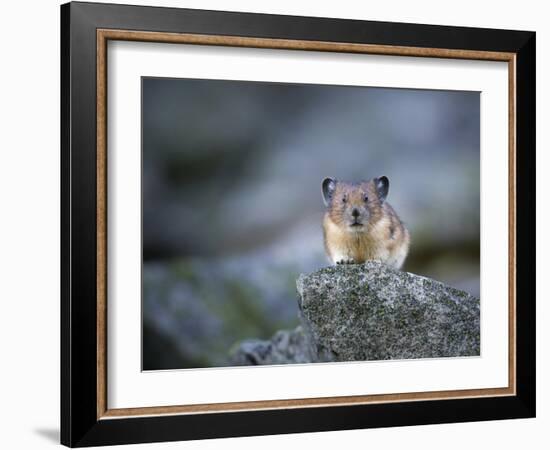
233 261 480 365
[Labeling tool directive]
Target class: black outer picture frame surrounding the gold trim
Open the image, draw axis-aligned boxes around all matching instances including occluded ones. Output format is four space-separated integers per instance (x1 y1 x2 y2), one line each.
61 2 536 447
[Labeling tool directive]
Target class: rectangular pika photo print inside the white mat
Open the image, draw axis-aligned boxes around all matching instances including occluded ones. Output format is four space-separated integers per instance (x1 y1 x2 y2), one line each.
141 77 480 371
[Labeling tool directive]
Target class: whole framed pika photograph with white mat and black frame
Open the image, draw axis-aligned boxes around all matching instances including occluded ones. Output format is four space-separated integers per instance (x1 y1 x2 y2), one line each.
61 3 535 447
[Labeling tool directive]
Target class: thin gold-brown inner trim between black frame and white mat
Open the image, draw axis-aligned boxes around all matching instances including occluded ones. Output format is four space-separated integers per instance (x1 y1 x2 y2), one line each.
96 29 516 420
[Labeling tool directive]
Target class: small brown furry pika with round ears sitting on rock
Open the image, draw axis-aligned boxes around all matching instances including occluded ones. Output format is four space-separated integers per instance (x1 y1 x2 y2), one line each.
322 176 410 269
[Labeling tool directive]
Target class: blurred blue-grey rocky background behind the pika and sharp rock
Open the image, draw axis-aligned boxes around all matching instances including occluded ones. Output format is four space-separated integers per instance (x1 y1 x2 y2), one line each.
142 78 480 370
